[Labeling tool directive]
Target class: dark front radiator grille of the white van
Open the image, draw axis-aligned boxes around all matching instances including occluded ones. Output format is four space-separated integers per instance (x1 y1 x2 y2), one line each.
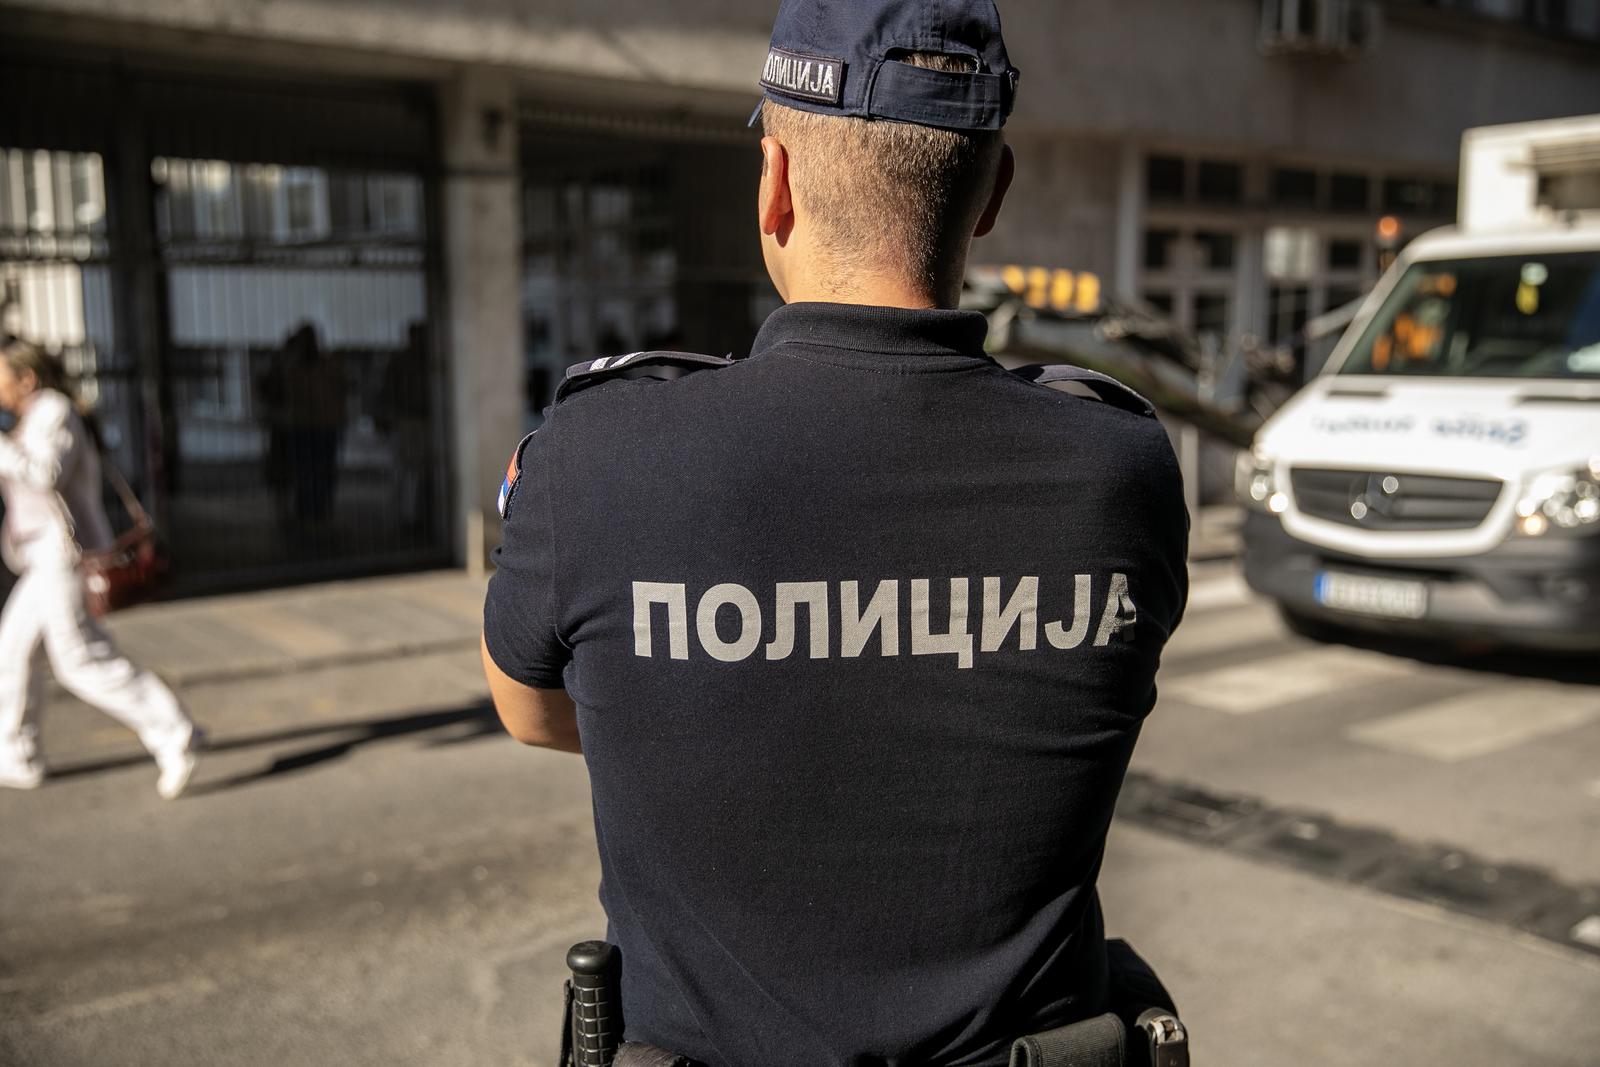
1290 467 1502 531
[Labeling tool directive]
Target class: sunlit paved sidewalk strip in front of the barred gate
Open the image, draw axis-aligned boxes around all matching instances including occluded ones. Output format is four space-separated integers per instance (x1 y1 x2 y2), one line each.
107 571 483 686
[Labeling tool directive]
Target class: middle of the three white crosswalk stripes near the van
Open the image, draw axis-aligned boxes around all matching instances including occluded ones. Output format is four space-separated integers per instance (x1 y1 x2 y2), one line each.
1162 648 1414 715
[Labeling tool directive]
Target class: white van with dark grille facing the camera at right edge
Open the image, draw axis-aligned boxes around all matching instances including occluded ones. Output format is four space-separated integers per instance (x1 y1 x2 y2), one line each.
1237 117 1600 649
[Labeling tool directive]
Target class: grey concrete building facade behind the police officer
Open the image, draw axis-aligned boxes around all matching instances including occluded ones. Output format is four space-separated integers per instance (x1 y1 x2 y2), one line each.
0 0 1600 589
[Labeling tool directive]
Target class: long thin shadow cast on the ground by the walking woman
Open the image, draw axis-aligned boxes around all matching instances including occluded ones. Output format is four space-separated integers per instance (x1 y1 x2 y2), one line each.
50 704 506 795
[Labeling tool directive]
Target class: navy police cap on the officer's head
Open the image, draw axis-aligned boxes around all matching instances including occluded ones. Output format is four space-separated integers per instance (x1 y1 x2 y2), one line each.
750 0 1021 130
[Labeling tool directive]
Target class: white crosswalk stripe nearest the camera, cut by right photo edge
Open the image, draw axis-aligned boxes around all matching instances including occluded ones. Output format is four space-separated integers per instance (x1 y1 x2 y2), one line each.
1346 681 1600 763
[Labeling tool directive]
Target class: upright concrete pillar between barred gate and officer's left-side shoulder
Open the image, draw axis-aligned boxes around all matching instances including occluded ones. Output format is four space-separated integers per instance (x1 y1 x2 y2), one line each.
438 70 525 574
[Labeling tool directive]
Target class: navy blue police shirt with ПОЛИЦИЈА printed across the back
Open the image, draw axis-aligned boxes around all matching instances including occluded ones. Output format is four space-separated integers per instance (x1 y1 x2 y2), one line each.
485 304 1187 1067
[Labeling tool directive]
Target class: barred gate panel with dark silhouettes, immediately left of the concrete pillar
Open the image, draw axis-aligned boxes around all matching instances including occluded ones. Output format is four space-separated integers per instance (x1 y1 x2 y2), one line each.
152 157 443 588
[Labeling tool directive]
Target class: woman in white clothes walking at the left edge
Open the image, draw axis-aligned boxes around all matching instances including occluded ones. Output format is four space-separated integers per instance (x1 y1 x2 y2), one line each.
0 341 200 800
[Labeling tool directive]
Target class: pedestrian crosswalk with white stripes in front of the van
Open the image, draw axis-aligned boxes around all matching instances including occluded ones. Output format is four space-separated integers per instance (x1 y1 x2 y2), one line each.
1158 569 1600 763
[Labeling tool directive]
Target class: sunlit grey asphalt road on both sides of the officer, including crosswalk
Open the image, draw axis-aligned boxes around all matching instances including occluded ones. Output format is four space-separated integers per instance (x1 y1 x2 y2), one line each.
0 571 1600 1067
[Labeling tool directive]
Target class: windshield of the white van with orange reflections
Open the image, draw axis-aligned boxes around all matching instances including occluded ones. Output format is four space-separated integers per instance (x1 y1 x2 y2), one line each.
1339 251 1600 378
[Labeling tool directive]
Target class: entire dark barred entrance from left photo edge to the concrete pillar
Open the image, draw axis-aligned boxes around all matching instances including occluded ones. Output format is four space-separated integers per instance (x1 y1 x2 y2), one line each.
0 54 450 590
